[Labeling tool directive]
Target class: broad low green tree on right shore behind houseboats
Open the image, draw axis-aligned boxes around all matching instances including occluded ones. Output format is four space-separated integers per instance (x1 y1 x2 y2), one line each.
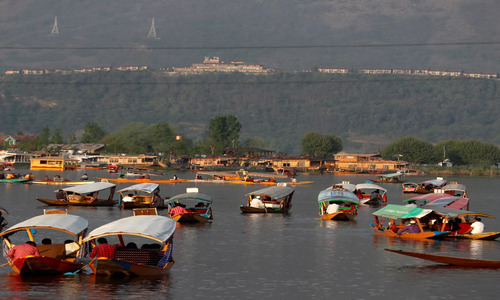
381 136 438 164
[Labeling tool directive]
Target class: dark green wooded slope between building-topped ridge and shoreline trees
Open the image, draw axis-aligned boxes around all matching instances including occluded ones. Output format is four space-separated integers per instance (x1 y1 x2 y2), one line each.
0 71 500 154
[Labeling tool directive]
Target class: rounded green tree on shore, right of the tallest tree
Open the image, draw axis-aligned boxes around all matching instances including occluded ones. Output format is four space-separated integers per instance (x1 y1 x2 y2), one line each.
302 132 342 158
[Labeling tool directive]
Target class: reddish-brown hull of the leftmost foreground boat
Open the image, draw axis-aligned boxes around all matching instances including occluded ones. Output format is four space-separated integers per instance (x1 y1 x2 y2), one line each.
11 256 83 276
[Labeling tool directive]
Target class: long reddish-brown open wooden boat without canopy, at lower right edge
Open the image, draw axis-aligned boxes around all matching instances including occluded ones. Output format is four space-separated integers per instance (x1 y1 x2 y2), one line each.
384 249 500 268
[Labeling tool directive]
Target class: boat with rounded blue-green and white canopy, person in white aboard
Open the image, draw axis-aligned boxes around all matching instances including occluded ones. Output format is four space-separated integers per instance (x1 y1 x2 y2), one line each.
318 188 360 221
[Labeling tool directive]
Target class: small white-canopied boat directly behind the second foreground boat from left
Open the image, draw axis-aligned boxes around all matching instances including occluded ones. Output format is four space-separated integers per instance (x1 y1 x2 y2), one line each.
118 183 164 208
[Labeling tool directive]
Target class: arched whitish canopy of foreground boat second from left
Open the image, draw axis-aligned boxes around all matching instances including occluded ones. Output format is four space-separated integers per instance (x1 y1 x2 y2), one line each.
83 215 177 243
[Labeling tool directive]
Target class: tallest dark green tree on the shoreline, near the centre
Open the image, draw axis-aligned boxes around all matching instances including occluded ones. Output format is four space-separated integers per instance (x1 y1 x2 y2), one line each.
206 115 241 151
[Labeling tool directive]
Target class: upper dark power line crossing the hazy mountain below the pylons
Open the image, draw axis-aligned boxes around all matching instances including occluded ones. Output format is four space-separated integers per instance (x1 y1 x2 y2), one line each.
0 41 500 50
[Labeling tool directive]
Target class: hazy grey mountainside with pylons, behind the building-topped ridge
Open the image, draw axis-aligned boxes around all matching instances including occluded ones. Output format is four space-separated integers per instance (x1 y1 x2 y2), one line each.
0 0 500 72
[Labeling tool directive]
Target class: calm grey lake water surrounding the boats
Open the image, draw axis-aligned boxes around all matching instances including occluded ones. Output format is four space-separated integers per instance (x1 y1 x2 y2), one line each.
0 170 500 299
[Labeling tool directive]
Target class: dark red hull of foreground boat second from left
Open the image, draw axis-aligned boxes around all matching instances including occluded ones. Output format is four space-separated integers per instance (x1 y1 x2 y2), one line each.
90 258 174 276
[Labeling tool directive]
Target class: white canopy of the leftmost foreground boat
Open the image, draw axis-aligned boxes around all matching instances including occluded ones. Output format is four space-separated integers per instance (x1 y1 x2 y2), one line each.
0 214 89 236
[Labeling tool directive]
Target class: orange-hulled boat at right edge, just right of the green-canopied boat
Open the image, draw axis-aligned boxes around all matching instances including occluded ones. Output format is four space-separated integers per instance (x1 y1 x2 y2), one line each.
433 207 500 240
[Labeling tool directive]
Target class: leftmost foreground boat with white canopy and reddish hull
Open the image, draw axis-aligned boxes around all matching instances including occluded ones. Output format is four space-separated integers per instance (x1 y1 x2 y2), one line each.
0 210 88 276
